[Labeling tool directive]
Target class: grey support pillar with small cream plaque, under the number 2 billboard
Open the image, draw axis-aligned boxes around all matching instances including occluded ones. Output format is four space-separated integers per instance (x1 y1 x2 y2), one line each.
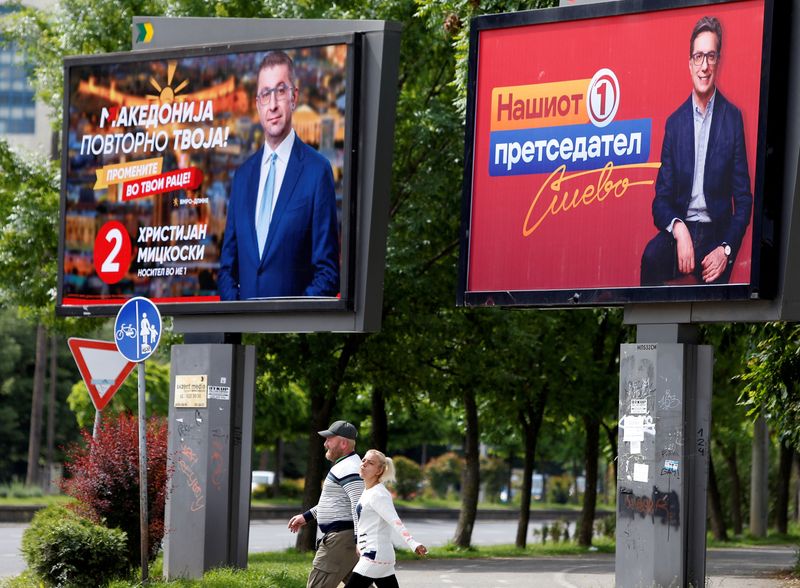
164 340 256 581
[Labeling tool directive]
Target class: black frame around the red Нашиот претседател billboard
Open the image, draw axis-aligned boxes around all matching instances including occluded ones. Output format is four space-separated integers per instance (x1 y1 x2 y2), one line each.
456 0 789 307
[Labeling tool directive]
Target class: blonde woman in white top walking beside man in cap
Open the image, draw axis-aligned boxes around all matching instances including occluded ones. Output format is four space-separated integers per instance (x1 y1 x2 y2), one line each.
345 449 428 588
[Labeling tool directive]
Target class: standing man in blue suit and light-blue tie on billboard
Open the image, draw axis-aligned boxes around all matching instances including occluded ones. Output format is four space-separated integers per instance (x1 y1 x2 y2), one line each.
217 51 339 300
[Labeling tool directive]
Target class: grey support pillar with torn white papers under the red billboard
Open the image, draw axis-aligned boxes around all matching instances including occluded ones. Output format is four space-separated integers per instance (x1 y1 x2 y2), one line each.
615 324 713 588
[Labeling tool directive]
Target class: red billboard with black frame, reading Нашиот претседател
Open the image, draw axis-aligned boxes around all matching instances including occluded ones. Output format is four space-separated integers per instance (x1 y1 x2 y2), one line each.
458 0 775 306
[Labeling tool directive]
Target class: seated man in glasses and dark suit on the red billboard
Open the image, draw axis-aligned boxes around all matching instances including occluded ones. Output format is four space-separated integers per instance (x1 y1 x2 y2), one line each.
641 16 753 286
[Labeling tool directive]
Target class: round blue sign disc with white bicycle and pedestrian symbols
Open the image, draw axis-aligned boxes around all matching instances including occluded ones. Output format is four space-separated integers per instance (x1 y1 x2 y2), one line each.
114 296 161 363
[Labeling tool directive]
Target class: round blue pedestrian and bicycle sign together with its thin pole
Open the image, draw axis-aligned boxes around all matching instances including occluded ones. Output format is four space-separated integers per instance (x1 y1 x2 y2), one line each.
114 296 161 584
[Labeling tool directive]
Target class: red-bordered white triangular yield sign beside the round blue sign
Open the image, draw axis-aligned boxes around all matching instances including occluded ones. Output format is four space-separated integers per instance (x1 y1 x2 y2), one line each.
67 337 136 410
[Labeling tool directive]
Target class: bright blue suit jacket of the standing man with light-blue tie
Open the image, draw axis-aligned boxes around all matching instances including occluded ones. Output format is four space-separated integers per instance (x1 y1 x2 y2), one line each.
217 137 339 300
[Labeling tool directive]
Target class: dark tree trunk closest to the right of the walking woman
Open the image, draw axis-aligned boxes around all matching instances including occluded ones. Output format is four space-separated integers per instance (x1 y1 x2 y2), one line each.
453 386 480 548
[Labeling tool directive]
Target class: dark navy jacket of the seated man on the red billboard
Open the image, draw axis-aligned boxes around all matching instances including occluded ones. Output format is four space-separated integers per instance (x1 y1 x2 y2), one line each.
653 89 753 259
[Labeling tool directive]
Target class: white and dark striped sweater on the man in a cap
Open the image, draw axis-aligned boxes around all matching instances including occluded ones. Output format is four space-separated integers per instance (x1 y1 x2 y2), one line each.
303 451 364 535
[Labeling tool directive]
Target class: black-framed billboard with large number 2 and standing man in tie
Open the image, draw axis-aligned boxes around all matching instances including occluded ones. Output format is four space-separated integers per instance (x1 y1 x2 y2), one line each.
57 34 361 315
